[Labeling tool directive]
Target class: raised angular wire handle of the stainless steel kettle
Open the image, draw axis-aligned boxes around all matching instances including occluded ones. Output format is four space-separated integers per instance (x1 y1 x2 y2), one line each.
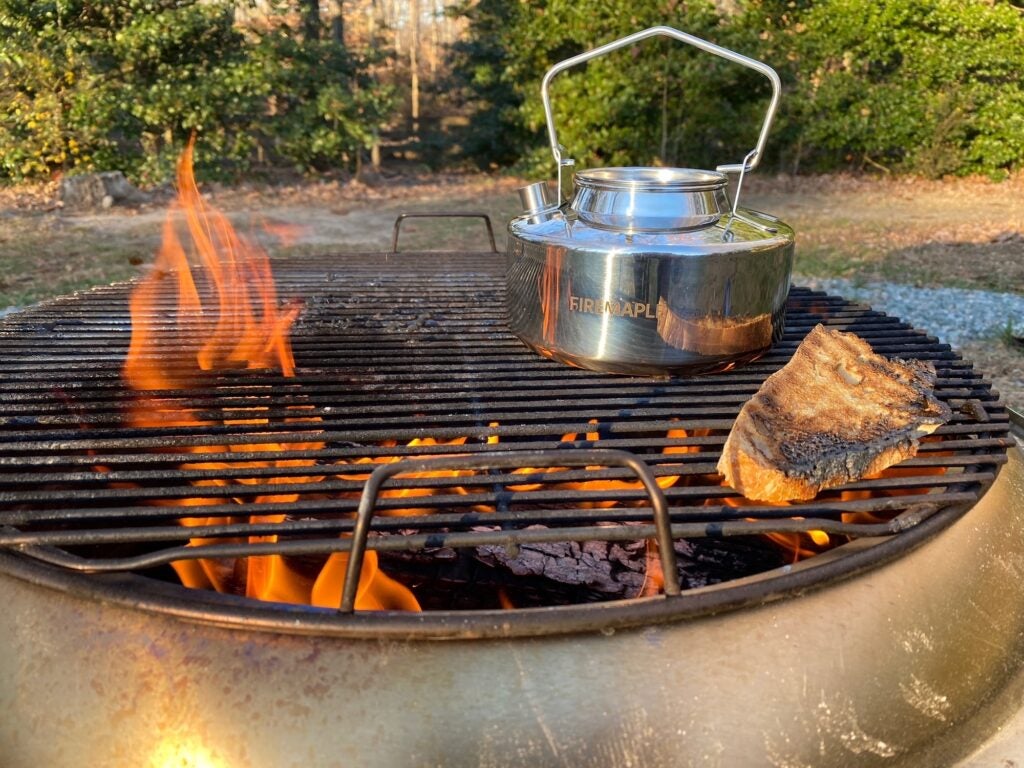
541 27 782 188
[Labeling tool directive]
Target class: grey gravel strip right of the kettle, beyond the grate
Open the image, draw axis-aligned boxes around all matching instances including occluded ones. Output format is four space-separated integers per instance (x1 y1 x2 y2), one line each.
797 278 1024 347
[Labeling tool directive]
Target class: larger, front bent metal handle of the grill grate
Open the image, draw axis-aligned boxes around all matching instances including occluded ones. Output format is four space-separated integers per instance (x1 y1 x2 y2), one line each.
340 449 682 613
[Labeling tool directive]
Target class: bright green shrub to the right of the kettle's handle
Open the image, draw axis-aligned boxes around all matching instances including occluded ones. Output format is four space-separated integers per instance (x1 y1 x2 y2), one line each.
748 0 1024 176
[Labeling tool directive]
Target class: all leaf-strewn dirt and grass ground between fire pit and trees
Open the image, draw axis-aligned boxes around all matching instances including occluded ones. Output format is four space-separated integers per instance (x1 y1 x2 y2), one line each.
0 169 1024 409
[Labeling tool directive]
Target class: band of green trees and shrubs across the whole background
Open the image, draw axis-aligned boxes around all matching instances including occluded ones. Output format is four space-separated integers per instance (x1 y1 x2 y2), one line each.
0 0 1024 185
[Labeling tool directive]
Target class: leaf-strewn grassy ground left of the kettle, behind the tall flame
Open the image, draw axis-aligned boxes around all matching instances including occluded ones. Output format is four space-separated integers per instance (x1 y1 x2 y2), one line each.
0 176 519 309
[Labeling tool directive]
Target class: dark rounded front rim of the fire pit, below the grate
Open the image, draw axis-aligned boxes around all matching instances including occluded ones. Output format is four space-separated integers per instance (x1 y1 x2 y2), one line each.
0 489 972 640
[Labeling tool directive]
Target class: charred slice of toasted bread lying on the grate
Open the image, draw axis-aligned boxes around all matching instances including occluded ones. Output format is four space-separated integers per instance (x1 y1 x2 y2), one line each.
718 326 950 502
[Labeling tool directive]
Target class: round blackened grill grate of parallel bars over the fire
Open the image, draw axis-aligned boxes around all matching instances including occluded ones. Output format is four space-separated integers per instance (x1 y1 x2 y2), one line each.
0 254 1010 602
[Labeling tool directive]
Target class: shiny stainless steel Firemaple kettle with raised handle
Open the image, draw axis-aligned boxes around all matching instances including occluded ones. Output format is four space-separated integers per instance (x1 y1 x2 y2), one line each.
507 27 794 375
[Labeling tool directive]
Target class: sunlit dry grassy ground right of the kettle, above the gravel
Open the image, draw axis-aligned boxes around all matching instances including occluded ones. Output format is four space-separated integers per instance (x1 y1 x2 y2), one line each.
748 176 1024 294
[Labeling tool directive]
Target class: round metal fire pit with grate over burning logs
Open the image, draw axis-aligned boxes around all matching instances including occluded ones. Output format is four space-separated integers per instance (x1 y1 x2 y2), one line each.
0 247 1024 766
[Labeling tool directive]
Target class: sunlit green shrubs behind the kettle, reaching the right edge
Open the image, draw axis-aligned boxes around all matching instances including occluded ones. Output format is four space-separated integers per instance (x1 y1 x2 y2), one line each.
453 0 1024 176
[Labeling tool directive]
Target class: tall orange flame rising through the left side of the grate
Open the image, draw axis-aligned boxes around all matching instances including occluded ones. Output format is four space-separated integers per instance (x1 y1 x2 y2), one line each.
123 142 419 610
